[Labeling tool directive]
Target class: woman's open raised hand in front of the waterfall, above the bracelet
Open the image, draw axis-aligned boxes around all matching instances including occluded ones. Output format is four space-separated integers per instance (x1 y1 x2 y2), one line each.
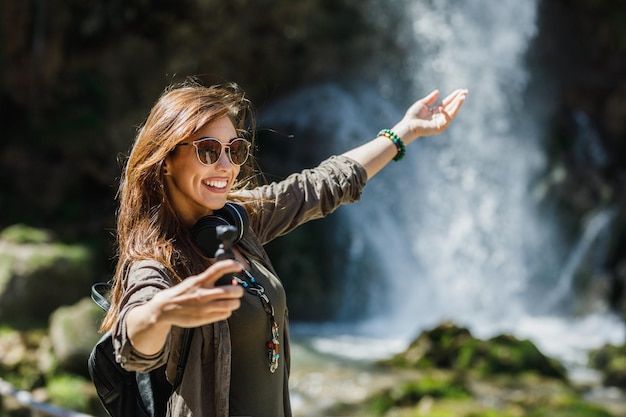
393 89 467 143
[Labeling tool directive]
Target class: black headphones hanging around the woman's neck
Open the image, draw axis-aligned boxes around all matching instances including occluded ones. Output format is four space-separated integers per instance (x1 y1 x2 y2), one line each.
191 203 250 258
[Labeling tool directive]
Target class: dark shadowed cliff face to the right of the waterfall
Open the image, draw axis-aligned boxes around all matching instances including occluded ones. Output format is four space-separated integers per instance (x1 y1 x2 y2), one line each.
530 0 626 313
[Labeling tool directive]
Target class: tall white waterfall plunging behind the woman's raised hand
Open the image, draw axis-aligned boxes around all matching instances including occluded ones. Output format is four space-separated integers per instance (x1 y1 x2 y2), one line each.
262 0 623 364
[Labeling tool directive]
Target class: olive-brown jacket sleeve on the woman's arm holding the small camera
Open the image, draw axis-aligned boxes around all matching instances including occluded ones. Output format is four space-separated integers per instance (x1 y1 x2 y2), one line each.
112 261 172 372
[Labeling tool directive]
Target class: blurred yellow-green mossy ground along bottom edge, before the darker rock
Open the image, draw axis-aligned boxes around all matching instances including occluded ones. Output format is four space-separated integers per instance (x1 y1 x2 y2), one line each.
329 369 615 417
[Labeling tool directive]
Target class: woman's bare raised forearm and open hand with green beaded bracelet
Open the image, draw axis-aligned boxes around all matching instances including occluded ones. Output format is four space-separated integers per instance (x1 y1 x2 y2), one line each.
344 89 467 179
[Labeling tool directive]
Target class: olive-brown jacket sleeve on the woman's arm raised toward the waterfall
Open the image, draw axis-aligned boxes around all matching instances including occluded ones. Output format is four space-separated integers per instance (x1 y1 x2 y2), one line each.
239 156 367 245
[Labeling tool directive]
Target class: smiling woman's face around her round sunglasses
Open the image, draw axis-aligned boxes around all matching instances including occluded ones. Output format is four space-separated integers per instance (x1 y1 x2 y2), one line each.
164 117 240 227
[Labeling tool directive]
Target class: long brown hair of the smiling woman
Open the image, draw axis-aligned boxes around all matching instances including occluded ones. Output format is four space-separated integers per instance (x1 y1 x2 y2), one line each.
100 79 256 331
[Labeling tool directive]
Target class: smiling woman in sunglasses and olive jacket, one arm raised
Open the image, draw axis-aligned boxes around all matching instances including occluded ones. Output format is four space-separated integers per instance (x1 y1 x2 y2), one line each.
102 82 467 417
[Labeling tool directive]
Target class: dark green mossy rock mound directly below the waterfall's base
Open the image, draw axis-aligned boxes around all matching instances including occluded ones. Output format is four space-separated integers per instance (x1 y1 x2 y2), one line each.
382 322 566 379
